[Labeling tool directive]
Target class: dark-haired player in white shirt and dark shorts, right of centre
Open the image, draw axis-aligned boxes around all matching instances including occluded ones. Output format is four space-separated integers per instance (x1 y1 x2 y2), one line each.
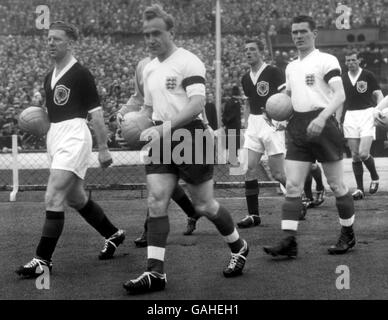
264 16 356 257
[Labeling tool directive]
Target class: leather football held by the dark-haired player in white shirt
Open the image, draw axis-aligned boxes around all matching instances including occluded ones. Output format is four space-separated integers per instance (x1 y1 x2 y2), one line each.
265 93 294 121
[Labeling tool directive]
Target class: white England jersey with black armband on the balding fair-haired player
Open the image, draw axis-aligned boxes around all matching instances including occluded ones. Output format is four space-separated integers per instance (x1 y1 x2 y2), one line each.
143 48 206 121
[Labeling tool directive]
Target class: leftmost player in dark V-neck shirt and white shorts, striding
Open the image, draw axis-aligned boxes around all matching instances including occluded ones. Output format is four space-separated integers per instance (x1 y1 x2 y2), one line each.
16 21 125 277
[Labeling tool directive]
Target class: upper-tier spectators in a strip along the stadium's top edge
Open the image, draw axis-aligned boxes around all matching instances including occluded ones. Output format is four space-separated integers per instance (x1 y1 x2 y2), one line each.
0 0 388 35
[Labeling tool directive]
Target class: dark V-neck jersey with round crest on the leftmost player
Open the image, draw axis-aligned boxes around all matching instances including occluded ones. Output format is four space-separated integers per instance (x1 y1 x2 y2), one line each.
44 62 101 122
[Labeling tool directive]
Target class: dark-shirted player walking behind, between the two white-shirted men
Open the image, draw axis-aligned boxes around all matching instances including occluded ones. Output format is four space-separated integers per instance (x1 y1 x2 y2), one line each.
237 40 286 228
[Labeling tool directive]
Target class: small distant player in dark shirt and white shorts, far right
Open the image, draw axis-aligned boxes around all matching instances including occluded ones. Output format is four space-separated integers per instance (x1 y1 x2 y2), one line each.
342 51 384 200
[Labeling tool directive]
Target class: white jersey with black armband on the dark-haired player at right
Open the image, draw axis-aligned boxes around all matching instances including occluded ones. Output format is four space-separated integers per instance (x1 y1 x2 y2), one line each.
286 49 342 112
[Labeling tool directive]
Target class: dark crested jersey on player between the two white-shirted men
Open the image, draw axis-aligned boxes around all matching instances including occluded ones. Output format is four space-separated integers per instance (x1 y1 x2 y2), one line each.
241 65 286 115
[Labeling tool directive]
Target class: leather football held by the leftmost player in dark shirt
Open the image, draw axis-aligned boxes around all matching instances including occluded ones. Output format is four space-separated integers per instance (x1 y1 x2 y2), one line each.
18 107 50 137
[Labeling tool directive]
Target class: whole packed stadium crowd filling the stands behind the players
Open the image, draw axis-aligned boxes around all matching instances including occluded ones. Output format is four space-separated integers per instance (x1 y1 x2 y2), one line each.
0 0 388 148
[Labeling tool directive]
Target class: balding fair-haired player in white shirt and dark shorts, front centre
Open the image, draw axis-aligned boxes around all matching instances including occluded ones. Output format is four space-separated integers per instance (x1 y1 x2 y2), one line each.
123 5 249 294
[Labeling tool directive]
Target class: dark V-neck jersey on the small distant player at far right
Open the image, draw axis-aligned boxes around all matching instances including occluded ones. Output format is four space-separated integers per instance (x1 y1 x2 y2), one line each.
342 69 380 110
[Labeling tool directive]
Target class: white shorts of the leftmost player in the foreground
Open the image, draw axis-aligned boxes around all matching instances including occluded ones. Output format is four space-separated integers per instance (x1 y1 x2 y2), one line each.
47 118 93 179
